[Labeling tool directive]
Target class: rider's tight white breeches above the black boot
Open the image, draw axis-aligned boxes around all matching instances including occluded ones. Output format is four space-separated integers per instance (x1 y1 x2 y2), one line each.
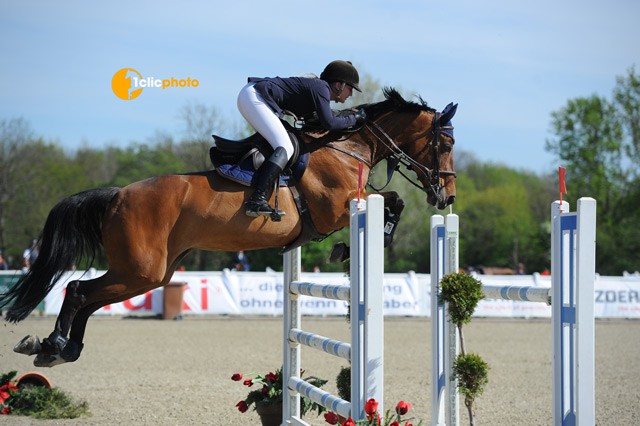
238 83 293 159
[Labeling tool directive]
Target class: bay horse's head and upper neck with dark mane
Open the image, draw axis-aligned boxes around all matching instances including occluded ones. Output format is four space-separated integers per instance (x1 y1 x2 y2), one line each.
367 88 458 209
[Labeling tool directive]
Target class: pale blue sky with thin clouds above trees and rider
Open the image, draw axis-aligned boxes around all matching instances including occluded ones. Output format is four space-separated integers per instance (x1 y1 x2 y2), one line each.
0 0 640 173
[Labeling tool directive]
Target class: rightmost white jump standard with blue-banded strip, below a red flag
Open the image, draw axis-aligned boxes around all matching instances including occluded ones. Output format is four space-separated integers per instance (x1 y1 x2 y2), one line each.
551 198 596 426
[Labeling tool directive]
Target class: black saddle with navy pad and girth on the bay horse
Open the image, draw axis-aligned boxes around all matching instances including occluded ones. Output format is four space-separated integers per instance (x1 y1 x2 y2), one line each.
209 122 327 253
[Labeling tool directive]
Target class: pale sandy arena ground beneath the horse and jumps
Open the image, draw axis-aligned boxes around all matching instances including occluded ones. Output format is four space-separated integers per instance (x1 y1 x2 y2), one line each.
0 317 640 426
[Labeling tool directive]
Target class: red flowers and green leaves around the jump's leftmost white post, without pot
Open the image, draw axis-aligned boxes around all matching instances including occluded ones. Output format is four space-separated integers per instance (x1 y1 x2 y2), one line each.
231 368 327 415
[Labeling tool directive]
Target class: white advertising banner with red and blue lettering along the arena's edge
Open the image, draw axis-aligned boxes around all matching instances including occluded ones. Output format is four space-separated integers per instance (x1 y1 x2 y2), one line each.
35 270 640 318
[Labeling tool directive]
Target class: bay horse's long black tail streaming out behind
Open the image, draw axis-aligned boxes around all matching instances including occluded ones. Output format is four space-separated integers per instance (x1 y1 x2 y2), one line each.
0 188 120 322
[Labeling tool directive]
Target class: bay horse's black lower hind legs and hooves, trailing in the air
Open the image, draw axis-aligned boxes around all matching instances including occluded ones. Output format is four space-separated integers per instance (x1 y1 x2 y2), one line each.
13 281 85 367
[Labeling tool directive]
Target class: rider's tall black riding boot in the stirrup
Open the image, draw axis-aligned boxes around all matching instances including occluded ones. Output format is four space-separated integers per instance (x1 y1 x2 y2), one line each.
244 147 288 218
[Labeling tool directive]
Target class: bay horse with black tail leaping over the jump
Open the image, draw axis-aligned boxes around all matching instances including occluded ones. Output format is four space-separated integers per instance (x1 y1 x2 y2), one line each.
0 88 457 367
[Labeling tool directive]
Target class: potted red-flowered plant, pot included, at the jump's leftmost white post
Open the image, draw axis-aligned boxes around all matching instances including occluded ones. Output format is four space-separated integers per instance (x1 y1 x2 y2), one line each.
231 368 327 426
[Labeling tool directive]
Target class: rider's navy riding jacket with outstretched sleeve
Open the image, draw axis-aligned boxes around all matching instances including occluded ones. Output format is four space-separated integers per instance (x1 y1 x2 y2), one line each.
249 77 356 130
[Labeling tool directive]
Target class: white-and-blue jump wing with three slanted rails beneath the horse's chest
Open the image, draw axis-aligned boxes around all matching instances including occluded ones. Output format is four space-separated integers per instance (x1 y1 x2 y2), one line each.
282 194 384 426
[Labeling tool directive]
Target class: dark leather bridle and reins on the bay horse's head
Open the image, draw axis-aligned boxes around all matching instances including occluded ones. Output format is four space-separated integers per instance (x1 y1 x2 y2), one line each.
364 112 456 195
